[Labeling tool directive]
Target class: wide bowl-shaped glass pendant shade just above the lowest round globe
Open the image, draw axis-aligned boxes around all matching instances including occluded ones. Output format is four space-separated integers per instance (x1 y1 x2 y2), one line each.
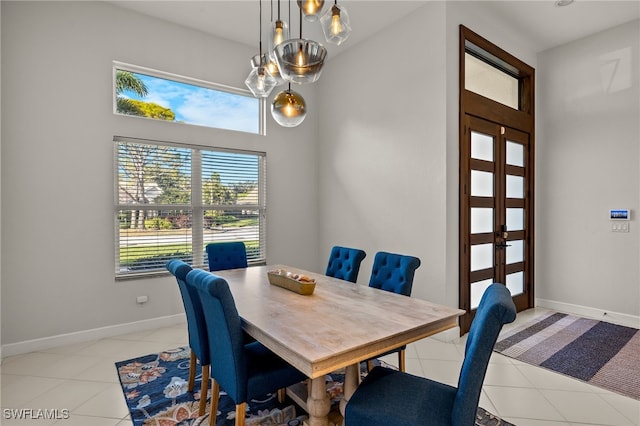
276 39 327 84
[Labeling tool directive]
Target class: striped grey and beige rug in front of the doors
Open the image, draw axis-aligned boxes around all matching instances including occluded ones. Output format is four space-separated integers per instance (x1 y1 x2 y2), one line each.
494 312 640 400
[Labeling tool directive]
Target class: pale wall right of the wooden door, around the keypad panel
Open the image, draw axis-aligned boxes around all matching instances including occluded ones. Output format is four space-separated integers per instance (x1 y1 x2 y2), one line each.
536 20 640 317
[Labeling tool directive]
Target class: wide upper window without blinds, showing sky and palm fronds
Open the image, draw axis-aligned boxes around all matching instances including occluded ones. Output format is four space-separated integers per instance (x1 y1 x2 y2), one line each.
113 63 264 134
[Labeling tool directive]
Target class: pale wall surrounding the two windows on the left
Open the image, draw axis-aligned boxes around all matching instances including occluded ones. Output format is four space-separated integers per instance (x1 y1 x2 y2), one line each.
1 1 318 345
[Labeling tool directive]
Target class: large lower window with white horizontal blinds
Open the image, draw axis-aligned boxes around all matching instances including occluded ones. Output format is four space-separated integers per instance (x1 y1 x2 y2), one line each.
114 137 266 278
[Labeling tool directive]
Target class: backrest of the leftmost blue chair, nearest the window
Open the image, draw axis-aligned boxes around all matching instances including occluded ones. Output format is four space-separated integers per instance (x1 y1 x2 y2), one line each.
166 259 211 365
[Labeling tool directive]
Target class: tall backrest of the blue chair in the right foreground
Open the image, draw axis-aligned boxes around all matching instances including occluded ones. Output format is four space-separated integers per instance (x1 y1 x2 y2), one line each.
451 283 516 425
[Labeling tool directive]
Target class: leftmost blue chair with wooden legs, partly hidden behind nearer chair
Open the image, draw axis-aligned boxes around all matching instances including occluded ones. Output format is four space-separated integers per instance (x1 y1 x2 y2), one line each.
166 259 211 416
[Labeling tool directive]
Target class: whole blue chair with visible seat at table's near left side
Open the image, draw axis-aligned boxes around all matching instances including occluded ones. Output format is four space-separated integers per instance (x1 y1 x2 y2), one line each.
187 269 306 426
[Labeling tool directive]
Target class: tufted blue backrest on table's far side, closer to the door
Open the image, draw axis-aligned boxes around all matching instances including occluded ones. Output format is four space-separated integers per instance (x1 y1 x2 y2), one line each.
369 251 420 296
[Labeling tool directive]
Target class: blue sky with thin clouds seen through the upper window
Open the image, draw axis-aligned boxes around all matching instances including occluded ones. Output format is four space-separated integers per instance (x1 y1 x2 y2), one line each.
123 73 260 133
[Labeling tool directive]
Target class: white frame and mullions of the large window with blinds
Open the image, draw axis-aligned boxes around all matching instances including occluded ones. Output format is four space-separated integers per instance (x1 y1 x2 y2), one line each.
113 136 267 280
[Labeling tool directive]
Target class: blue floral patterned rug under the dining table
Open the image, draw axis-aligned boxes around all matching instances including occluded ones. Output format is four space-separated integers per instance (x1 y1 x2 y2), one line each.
116 347 513 426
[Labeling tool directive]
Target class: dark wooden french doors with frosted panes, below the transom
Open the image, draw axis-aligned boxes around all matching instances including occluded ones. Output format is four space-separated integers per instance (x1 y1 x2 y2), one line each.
461 116 533 332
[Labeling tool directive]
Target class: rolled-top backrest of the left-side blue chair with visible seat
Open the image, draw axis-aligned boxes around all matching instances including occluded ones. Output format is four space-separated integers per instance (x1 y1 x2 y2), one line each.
187 269 248 404
